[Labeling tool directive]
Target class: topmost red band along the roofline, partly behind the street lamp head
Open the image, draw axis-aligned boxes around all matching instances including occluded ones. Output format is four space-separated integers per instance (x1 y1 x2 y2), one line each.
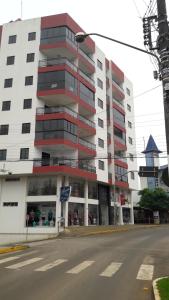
41 13 95 53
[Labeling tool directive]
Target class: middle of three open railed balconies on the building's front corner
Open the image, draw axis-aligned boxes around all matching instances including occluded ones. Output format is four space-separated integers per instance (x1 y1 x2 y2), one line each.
36 106 96 136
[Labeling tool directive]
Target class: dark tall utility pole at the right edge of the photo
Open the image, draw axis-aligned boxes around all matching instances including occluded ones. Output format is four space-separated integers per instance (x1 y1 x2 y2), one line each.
157 0 169 157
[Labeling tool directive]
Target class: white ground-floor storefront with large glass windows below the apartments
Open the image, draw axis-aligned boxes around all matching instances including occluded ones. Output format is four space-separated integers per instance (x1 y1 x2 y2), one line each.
0 175 134 242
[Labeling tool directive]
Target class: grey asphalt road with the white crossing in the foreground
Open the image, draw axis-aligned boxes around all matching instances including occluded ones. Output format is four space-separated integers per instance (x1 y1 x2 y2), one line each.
0 226 169 300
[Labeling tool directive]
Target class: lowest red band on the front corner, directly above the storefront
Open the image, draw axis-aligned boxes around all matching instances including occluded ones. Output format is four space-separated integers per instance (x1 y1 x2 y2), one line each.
33 166 97 180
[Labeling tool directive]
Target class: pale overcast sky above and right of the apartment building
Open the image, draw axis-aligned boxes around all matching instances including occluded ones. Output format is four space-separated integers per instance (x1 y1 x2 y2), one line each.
0 0 169 165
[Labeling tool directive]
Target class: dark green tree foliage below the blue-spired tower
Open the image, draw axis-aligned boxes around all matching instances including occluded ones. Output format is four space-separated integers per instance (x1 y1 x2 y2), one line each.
138 188 169 211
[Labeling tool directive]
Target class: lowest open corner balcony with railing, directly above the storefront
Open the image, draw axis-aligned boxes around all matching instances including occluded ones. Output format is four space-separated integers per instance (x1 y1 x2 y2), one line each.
33 157 97 180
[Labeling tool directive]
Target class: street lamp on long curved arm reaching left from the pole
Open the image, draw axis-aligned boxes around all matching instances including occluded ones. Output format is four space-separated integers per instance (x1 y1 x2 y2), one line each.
75 32 161 72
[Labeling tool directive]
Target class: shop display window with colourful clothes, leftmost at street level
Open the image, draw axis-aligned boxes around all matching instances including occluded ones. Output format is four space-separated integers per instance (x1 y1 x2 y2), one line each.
25 201 56 227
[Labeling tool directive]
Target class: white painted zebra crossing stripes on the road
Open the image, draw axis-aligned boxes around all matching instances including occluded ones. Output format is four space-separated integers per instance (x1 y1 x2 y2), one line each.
0 255 154 281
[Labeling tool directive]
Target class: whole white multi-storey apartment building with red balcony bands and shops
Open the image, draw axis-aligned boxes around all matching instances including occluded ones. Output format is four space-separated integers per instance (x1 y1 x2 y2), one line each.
0 14 138 242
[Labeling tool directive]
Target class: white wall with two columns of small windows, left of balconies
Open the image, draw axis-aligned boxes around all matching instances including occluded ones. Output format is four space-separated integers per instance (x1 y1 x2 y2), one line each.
0 18 40 174
